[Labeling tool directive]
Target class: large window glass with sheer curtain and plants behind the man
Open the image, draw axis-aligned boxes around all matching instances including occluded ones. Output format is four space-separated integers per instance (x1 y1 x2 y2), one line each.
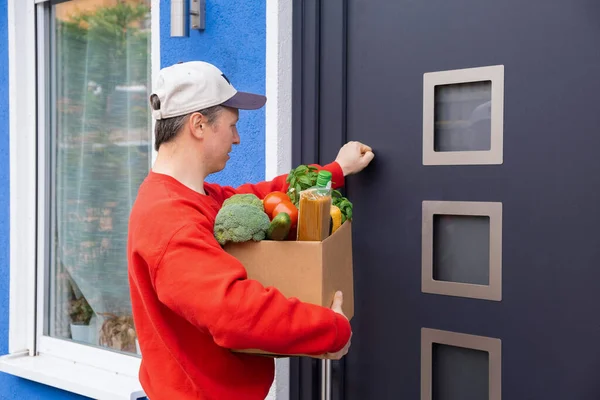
46 0 151 353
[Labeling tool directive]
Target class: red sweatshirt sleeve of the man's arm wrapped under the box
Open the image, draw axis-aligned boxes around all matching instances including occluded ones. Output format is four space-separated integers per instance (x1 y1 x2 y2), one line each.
155 224 351 355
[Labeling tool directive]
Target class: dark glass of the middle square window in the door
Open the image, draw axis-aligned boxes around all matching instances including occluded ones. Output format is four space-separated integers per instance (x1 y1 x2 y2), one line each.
433 215 490 285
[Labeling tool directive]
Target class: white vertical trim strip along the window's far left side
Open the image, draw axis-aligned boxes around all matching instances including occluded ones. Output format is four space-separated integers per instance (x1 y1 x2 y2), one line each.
8 0 37 355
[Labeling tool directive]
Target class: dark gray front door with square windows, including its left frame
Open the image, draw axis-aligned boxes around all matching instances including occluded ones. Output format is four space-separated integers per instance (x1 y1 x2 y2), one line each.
292 0 600 400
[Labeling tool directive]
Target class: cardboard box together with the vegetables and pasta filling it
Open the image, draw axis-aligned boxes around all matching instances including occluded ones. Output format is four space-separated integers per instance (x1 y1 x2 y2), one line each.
214 165 354 355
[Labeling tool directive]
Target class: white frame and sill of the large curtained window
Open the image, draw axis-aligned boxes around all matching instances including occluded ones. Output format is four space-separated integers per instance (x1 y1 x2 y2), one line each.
0 0 160 400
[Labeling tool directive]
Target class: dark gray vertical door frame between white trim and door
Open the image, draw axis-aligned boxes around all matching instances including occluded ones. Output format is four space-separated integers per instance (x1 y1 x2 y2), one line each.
290 0 348 400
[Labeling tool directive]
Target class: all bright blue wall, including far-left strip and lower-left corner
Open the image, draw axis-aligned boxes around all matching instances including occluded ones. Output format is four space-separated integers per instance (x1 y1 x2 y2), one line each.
0 0 265 400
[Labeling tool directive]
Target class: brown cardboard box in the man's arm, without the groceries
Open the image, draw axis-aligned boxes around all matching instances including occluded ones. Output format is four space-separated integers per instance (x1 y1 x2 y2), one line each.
225 221 354 354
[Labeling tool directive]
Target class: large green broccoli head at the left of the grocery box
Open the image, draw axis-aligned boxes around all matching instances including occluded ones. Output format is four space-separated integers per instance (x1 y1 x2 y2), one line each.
214 203 271 246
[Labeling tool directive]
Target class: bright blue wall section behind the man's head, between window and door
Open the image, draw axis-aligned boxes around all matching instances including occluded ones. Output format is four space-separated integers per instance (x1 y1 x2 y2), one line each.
160 0 266 186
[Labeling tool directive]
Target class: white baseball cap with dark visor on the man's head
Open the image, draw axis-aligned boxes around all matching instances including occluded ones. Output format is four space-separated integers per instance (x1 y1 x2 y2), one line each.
152 61 267 120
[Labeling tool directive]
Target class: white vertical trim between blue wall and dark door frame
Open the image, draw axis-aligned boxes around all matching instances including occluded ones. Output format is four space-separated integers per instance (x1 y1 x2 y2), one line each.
265 0 293 400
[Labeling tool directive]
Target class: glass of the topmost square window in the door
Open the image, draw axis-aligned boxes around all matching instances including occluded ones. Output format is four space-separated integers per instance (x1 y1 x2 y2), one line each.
434 81 492 151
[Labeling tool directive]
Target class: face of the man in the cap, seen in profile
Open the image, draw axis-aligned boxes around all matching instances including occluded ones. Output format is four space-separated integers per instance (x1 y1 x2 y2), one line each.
204 107 240 174
